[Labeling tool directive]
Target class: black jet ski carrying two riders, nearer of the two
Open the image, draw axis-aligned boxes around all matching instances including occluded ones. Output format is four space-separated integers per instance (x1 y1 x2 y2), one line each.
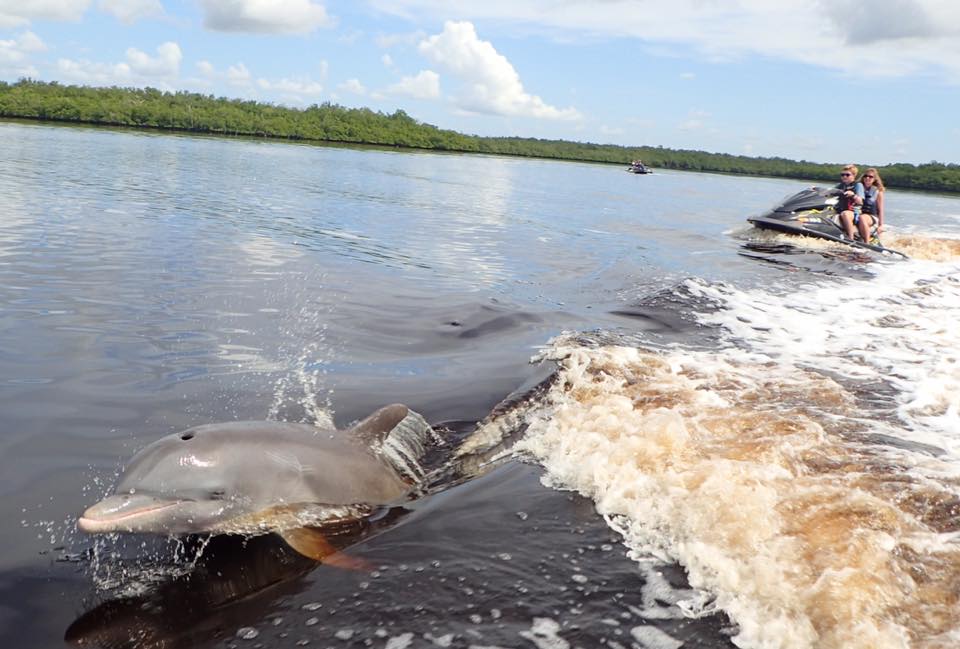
747 187 907 259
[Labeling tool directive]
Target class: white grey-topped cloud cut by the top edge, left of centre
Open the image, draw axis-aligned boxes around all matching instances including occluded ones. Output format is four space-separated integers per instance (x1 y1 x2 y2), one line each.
200 0 333 34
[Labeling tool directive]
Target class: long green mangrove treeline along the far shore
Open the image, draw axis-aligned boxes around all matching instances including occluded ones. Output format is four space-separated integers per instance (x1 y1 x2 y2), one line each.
0 79 960 192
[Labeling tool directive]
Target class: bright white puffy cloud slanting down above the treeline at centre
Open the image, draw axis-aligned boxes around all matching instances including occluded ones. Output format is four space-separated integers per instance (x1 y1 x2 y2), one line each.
419 21 580 119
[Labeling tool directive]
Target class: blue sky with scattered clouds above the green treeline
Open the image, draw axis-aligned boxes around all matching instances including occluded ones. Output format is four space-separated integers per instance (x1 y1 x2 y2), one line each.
0 0 960 164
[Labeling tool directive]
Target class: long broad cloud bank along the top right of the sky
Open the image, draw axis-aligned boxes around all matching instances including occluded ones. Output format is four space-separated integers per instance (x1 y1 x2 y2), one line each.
376 0 960 81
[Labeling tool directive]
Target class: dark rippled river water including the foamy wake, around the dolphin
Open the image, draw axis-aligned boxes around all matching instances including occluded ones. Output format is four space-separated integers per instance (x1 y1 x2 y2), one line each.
0 123 960 649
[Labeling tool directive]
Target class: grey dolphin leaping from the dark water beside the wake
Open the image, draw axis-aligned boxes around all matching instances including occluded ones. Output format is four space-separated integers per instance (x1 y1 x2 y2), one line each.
77 404 440 567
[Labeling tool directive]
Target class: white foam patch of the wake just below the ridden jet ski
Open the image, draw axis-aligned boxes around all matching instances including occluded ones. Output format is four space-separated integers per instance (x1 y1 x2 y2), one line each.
688 251 960 448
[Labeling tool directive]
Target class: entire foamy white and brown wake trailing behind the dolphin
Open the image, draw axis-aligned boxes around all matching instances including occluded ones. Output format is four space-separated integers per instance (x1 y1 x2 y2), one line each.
520 237 960 649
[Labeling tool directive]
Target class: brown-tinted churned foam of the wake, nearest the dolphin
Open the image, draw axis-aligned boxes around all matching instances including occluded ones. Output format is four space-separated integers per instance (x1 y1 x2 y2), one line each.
522 339 960 649
